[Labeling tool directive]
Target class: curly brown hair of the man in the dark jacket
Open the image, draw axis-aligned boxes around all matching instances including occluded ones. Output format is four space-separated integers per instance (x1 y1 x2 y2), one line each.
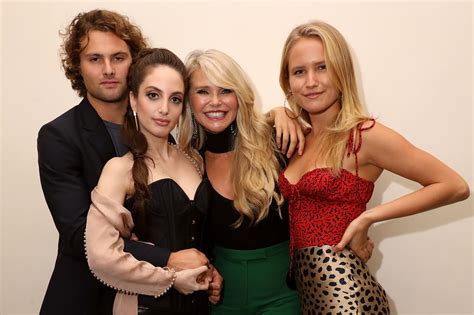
59 10 148 97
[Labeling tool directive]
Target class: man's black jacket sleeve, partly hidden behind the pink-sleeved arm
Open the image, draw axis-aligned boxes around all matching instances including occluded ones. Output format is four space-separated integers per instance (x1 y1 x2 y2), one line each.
37 124 171 266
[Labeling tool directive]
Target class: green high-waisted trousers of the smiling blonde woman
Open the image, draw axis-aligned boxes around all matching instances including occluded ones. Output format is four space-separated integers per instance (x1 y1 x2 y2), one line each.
211 242 300 315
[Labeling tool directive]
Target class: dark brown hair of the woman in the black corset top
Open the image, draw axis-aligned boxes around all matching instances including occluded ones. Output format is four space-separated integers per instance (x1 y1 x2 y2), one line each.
122 48 187 235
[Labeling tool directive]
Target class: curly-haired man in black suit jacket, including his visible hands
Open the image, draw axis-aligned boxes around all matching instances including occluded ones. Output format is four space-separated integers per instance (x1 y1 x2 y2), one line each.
38 10 222 314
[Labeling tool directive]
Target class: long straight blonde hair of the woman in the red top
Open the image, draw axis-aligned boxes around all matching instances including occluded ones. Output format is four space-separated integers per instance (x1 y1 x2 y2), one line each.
280 21 371 174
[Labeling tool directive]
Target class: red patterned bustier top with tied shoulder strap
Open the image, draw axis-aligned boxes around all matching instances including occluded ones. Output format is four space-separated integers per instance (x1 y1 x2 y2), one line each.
278 120 375 262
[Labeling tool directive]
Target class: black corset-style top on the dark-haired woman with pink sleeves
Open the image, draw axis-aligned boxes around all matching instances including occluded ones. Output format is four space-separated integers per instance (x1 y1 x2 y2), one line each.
125 178 211 314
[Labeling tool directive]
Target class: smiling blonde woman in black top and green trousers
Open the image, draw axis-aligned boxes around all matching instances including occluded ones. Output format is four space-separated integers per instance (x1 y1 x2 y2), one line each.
180 50 299 315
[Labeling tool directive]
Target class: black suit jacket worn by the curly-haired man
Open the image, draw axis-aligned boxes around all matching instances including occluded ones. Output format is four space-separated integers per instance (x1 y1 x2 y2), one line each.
38 99 170 315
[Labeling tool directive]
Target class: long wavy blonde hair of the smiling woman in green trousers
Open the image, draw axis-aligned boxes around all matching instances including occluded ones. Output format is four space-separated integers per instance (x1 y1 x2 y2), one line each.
182 49 283 227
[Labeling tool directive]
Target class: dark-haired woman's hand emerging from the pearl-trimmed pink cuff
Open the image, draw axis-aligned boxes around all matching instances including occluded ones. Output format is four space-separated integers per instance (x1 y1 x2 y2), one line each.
173 265 211 294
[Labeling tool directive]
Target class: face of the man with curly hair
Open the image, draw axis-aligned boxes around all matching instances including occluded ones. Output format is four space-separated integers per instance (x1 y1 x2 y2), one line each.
80 30 132 103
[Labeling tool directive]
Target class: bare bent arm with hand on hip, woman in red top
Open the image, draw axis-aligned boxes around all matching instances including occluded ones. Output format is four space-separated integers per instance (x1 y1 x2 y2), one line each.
335 123 469 254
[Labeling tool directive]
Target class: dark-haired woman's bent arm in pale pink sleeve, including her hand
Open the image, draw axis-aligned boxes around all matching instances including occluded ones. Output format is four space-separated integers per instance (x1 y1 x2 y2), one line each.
85 157 208 296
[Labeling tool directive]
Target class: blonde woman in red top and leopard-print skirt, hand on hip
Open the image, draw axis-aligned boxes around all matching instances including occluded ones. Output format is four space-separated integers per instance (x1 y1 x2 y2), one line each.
279 21 469 314
